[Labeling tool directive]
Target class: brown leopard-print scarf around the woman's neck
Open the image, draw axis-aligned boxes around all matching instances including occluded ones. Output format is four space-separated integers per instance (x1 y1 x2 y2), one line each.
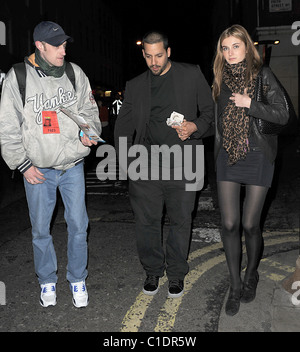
222 60 255 165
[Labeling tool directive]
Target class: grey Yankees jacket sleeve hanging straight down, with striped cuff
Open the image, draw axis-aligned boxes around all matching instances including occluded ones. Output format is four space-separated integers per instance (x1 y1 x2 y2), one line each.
0 69 32 172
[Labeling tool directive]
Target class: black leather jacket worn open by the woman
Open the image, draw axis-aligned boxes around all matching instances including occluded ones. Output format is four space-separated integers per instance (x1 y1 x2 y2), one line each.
214 66 289 164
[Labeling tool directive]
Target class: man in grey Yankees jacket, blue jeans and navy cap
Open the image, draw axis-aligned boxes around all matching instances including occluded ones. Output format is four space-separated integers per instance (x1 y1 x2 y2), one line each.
0 21 101 308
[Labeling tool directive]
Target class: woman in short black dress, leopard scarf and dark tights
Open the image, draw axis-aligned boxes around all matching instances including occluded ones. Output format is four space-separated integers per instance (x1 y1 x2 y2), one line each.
213 25 288 315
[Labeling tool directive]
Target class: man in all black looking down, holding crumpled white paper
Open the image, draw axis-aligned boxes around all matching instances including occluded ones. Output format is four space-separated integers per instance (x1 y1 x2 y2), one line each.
115 32 214 298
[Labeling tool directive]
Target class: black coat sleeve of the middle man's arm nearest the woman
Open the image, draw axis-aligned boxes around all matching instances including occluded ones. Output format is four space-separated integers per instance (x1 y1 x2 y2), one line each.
193 66 214 138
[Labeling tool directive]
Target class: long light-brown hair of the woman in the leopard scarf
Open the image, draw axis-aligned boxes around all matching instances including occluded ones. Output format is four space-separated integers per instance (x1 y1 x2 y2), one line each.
212 24 262 101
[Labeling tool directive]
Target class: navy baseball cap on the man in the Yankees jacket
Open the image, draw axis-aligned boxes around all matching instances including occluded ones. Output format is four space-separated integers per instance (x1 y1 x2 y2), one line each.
33 21 73 46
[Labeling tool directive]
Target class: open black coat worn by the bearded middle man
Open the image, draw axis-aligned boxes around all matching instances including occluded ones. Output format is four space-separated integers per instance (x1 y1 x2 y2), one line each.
115 62 214 149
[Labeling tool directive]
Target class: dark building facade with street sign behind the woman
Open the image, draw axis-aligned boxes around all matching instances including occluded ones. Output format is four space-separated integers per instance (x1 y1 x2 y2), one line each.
257 0 300 116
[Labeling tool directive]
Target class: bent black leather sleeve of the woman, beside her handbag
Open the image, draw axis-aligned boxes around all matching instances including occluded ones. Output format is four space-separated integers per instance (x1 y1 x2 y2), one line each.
248 67 289 125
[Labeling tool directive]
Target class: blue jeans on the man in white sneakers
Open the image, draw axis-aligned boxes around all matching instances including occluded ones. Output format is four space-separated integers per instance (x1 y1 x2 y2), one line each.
24 163 88 284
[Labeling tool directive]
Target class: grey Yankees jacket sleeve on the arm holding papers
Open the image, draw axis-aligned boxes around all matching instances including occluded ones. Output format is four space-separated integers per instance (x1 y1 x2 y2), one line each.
72 63 102 135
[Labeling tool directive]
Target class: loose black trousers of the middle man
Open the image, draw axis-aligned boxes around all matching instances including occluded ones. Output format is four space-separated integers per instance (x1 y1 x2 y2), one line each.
129 180 196 280
